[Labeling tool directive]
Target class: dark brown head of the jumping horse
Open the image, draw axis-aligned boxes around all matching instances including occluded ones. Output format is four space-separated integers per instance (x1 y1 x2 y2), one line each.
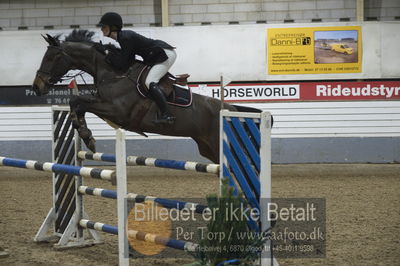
32 34 73 96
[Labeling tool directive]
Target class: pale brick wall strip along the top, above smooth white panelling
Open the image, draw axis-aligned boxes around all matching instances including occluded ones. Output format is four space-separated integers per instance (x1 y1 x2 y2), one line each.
0 0 400 30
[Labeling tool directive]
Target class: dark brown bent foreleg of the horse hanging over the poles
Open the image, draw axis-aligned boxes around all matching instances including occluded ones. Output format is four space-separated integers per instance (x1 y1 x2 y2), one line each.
69 96 97 152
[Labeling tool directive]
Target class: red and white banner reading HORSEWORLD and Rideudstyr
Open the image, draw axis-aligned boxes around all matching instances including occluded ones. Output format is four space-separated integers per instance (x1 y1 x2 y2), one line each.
191 81 400 102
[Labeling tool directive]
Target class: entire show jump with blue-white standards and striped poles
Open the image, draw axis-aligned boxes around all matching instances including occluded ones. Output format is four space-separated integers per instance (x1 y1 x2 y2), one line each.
0 106 278 265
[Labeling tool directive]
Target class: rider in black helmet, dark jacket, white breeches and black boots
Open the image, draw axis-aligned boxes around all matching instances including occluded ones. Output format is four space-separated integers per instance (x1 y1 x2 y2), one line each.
99 12 176 124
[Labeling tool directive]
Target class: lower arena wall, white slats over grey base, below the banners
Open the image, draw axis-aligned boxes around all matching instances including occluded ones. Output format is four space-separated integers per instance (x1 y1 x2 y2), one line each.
0 101 400 163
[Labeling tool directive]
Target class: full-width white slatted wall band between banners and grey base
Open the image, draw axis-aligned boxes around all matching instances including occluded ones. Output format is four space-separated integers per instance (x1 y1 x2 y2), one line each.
0 101 400 141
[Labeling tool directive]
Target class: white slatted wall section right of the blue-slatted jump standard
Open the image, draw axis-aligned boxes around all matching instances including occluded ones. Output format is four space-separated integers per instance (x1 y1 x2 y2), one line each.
238 101 400 138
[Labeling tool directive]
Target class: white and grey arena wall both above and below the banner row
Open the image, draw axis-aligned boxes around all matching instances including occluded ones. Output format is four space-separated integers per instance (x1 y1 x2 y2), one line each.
0 22 400 163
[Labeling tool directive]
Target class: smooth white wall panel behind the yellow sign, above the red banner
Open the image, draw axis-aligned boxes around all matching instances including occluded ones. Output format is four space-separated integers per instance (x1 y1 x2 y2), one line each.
0 22 400 86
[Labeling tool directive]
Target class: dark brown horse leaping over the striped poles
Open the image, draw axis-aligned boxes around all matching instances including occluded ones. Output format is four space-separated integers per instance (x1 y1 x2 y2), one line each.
33 30 260 163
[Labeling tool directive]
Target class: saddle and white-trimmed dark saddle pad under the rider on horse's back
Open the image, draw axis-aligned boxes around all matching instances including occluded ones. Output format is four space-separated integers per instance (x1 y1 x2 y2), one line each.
128 65 192 108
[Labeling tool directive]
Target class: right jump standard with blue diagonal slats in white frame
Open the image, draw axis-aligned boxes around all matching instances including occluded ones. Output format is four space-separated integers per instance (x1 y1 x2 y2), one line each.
220 110 278 265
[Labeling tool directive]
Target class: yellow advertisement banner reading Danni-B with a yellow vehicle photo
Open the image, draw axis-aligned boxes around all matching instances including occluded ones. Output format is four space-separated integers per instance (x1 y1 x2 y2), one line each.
267 26 362 75
